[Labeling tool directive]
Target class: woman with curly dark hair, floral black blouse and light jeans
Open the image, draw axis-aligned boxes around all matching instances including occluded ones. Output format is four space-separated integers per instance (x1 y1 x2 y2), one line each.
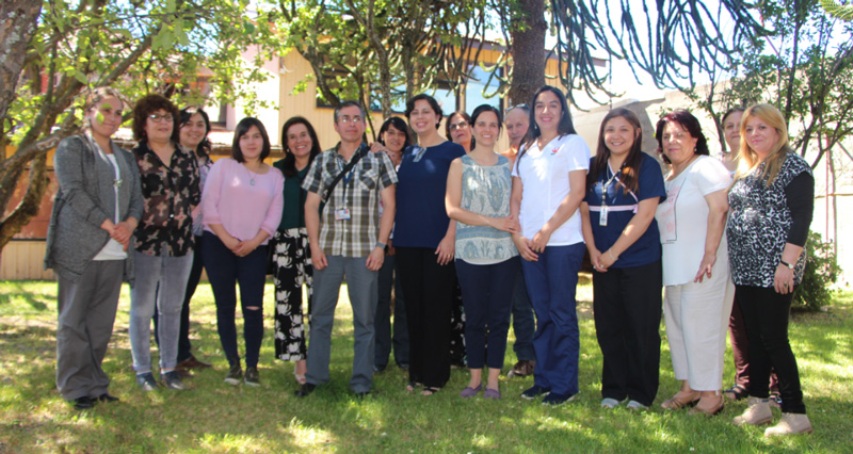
130 95 201 391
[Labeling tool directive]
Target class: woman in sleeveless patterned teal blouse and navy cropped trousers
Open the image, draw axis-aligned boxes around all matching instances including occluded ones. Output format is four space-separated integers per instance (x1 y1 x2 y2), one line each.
445 104 520 399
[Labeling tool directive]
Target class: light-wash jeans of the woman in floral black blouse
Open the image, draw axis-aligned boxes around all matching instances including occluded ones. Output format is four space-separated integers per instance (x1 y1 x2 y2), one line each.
130 251 193 374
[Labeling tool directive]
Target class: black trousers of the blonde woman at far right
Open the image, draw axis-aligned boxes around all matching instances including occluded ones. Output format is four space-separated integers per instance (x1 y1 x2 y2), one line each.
735 285 806 413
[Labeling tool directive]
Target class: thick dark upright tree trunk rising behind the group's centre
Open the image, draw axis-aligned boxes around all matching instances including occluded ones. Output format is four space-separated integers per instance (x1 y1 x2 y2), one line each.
509 0 548 105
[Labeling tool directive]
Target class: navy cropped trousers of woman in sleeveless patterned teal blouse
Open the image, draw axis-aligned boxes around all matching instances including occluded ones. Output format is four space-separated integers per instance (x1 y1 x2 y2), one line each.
456 257 519 369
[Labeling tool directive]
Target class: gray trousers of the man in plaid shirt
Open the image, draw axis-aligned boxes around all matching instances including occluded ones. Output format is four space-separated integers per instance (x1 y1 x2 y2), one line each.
306 256 379 393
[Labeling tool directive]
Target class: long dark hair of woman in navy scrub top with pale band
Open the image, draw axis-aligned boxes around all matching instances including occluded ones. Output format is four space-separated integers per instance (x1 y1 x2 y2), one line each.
586 108 643 194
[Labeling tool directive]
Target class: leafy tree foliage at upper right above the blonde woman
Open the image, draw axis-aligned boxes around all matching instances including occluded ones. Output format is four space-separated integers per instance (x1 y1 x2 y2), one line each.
697 0 853 167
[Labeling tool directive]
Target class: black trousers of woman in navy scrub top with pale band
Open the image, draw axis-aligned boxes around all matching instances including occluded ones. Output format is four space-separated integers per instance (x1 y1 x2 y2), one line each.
592 261 663 406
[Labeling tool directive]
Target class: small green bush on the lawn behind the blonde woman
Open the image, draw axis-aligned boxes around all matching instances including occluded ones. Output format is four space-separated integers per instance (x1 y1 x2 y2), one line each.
792 231 841 312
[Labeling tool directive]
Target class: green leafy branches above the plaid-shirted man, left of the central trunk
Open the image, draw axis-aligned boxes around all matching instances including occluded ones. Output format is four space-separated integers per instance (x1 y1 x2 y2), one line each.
266 0 487 124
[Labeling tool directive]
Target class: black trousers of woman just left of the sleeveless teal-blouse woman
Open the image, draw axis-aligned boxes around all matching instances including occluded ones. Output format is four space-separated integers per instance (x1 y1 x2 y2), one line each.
397 247 456 388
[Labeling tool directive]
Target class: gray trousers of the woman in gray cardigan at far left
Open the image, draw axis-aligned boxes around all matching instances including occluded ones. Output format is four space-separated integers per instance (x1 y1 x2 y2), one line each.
56 260 124 400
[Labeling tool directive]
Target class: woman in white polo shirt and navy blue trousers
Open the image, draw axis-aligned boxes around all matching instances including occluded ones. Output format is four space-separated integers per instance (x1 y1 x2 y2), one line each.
512 86 590 405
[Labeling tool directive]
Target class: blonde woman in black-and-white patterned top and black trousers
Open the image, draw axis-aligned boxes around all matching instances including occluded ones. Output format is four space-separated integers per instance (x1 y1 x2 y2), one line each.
726 104 814 437
